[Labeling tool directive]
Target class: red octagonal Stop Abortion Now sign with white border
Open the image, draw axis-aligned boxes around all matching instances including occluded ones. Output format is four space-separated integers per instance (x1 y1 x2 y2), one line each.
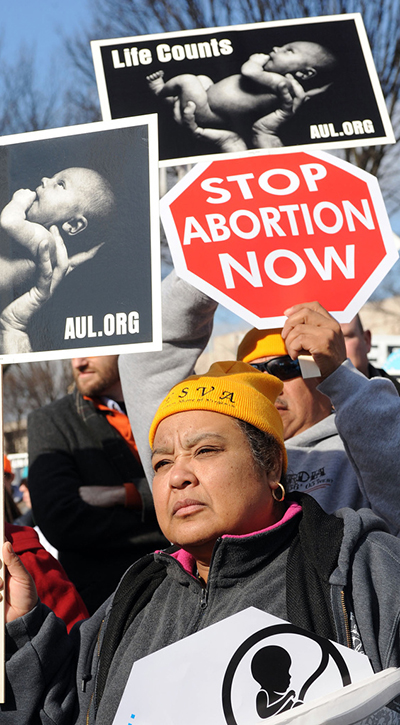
161 151 398 328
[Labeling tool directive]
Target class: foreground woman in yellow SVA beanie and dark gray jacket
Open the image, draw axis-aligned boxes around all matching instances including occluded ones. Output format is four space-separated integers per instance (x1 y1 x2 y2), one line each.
0 362 400 725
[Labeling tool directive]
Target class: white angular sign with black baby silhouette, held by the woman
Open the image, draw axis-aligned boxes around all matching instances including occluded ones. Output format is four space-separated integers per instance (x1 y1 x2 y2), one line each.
113 607 384 725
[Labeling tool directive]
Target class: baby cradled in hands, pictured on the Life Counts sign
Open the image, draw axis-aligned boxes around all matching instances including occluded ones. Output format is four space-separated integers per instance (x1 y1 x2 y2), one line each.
147 40 338 151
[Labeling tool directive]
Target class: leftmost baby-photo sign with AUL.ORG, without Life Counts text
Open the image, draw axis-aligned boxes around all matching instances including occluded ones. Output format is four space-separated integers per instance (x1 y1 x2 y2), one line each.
0 115 161 363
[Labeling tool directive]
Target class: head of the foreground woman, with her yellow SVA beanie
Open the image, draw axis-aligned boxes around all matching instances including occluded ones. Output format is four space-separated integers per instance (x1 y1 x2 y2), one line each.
149 362 287 582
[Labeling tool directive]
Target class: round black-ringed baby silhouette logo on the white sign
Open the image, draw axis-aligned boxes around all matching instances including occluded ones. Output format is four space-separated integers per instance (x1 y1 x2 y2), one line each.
222 624 351 725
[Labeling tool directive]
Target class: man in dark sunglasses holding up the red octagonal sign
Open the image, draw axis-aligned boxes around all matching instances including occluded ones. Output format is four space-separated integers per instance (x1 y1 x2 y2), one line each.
237 303 400 534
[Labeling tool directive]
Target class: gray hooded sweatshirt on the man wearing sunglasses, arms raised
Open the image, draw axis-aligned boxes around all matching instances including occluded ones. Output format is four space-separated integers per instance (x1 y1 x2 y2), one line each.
119 272 400 535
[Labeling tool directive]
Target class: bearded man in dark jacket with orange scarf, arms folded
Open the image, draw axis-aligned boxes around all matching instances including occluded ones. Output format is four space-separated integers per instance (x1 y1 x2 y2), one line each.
28 355 166 613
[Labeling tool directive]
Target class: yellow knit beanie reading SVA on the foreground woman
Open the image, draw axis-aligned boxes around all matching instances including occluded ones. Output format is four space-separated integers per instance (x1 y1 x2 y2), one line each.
149 361 287 471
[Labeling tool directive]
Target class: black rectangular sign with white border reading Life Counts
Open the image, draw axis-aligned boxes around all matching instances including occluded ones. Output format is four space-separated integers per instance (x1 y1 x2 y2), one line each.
92 13 395 166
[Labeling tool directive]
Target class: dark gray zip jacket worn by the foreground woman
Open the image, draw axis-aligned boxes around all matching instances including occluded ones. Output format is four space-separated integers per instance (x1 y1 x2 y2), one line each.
0 497 400 725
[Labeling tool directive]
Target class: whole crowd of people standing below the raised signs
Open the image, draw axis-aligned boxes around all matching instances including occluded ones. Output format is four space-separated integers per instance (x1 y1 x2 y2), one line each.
0 273 400 725
